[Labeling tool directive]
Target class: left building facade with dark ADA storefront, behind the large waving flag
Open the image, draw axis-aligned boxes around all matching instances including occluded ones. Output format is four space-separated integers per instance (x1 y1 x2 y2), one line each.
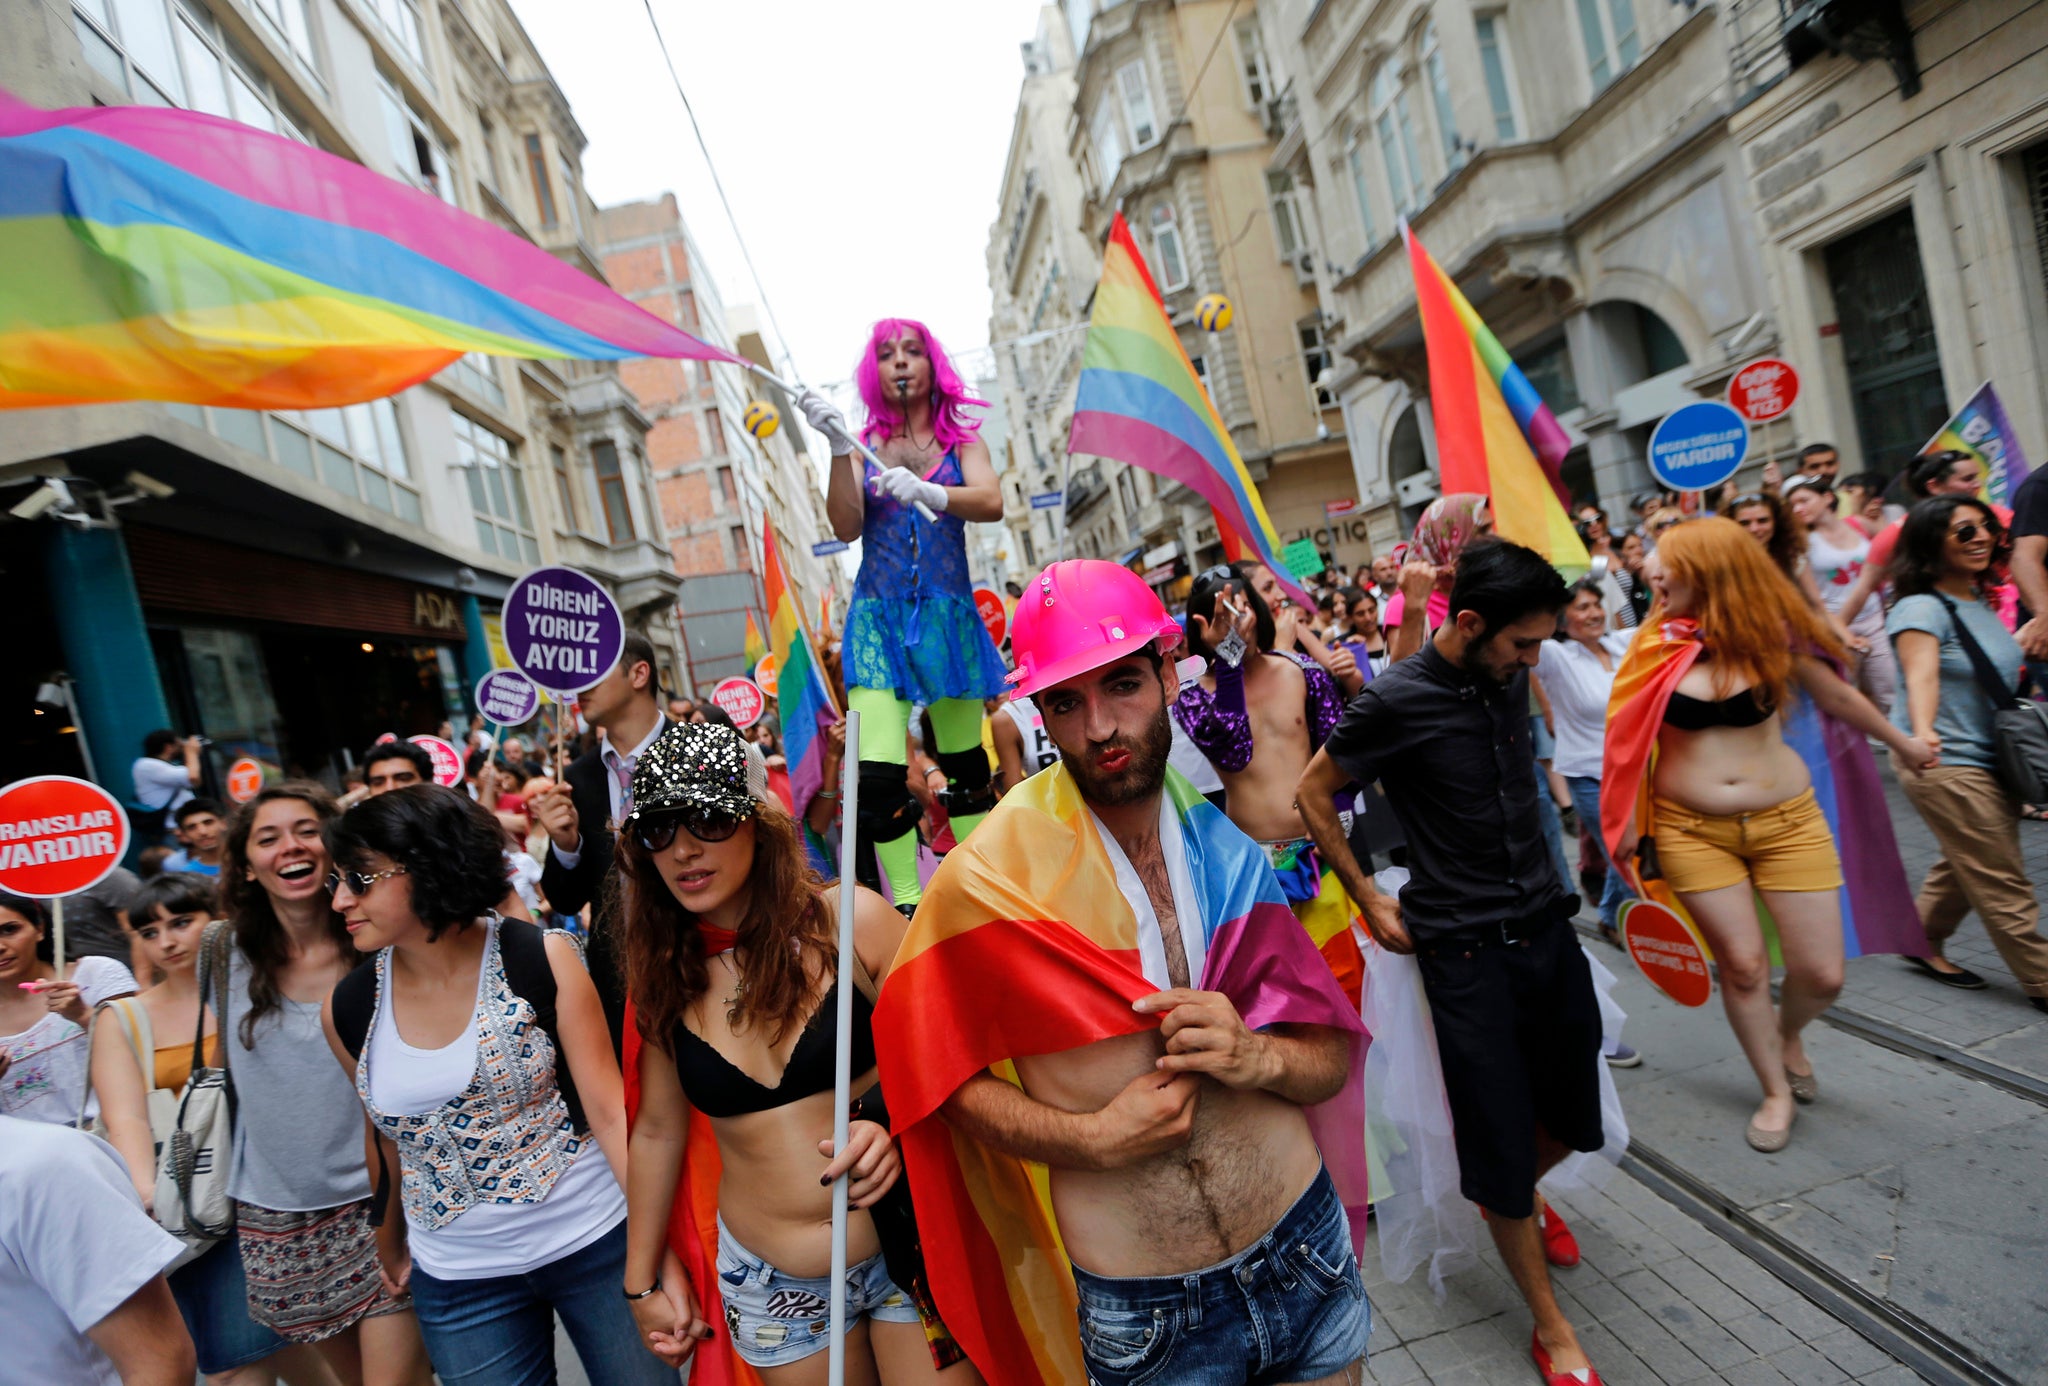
0 0 684 796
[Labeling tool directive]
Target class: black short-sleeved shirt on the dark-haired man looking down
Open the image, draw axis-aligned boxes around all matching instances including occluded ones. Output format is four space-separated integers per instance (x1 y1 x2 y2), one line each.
1323 641 1565 940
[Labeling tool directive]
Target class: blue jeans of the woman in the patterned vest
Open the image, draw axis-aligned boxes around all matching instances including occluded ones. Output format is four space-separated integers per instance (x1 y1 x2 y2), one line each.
412 1218 676 1386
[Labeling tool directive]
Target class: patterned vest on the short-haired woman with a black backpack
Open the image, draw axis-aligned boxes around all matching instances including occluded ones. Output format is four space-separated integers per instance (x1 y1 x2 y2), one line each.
356 923 586 1228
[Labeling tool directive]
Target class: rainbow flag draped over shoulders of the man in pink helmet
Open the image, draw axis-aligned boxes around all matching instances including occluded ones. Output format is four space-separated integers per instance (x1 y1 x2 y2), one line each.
874 766 1366 1386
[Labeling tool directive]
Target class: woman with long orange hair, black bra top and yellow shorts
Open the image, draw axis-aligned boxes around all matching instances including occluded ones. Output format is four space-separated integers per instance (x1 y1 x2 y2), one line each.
1599 520 1935 1153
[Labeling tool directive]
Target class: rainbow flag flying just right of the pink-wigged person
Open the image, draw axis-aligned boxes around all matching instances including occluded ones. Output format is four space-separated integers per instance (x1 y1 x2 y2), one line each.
1067 213 1315 612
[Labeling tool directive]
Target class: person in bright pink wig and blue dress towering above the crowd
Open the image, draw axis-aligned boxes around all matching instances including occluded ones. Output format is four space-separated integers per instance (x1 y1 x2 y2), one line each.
799 317 1004 913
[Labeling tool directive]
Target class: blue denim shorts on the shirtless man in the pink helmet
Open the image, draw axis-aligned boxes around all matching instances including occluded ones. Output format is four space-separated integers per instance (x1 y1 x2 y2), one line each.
1073 1171 1372 1386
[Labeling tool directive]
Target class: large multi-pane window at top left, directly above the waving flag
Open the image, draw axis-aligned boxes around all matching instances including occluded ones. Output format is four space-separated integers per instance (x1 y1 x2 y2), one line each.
72 0 311 143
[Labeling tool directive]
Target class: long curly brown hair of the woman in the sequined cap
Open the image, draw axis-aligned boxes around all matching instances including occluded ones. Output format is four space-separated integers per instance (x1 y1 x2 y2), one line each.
614 800 840 1052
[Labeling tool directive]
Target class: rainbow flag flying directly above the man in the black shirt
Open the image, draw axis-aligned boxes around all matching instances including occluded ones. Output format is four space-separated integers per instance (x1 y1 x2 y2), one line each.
1401 221 1591 573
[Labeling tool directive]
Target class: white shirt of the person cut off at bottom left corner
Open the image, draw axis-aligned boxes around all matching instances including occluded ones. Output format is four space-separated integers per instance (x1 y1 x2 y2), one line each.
0 1116 184 1386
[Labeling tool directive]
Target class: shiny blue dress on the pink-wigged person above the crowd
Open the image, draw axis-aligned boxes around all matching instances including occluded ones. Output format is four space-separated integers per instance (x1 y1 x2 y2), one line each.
844 452 1006 706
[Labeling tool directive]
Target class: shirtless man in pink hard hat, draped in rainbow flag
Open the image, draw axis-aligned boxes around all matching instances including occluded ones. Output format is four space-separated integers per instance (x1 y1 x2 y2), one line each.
874 559 1370 1386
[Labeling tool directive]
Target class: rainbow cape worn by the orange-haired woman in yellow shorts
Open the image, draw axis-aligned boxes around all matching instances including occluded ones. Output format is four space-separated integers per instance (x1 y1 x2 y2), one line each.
1599 616 1933 958
